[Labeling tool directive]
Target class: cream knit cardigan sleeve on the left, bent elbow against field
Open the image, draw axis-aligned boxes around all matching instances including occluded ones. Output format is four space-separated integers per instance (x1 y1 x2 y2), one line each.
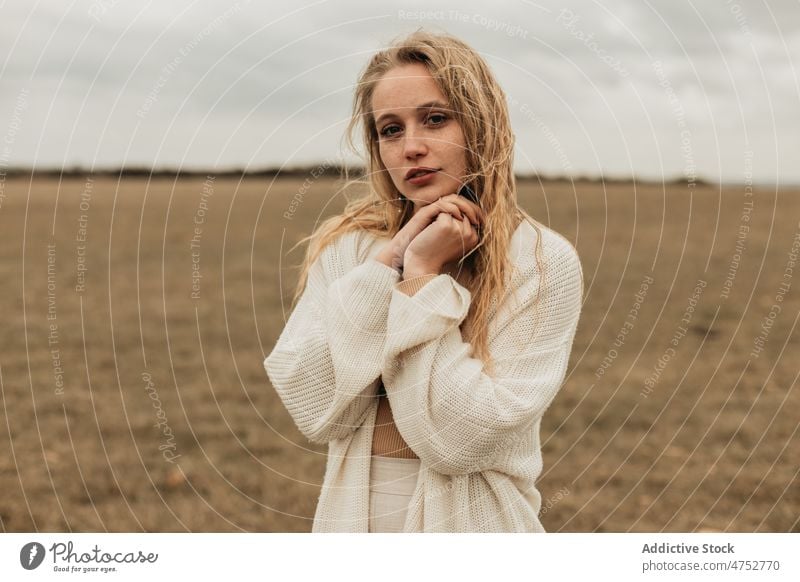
264 233 400 443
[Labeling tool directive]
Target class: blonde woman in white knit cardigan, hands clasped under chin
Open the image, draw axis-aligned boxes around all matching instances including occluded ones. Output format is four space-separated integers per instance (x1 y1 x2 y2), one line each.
264 31 583 532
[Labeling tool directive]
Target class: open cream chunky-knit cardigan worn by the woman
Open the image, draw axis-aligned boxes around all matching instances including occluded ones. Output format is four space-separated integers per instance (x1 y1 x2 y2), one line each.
264 220 583 532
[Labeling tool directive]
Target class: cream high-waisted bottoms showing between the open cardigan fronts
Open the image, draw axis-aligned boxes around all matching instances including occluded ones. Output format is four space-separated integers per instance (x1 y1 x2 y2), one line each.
369 455 420 533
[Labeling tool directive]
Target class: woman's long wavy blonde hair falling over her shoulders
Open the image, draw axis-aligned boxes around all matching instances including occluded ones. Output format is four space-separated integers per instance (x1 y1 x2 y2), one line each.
294 29 543 372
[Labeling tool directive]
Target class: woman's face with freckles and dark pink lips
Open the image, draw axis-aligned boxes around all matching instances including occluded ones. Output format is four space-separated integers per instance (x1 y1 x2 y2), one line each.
372 63 467 213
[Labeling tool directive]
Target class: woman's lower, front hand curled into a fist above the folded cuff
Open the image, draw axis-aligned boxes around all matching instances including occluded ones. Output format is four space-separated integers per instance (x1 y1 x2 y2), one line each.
403 212 480 278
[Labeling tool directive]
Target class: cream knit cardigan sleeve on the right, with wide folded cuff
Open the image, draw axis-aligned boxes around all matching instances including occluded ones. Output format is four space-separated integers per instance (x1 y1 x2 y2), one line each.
383 243 583 475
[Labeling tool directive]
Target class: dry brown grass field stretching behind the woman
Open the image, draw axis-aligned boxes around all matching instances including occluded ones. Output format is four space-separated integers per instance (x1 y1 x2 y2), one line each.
0 176 800 532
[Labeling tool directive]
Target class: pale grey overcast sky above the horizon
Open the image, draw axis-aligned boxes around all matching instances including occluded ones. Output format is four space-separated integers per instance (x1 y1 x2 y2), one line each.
0 0 800 183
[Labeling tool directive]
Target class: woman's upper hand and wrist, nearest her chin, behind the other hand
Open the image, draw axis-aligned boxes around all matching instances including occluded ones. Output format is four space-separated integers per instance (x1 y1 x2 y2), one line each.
376 194 484 269
